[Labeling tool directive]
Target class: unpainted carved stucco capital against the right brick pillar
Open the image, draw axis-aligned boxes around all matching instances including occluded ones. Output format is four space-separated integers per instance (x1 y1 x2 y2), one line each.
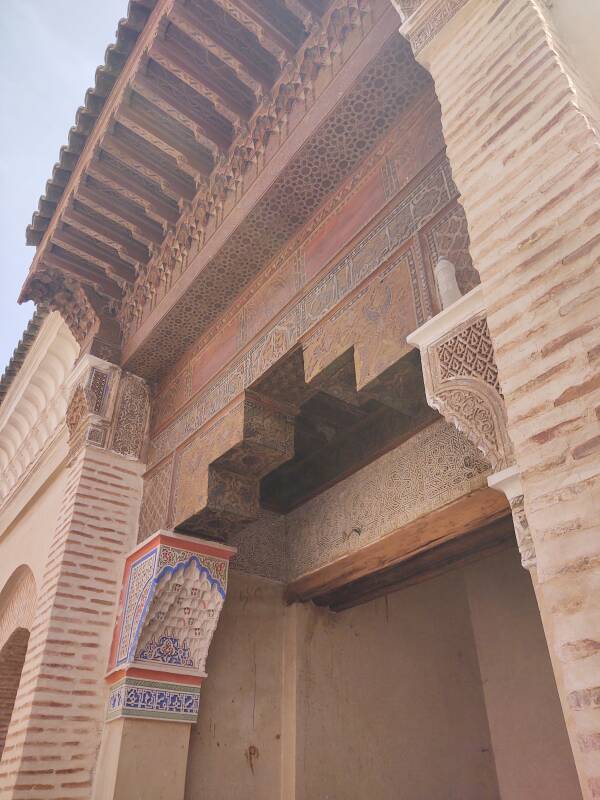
407 287 513 469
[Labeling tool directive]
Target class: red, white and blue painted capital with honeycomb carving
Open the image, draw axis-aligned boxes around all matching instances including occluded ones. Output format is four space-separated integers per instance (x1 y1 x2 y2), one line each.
107 531 235 722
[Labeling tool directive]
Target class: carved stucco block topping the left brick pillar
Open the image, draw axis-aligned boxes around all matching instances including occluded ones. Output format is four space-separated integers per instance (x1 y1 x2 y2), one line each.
65 354 150 461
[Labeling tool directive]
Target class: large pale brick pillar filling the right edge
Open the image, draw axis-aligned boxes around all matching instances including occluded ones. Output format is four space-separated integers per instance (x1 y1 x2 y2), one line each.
396 0 600 798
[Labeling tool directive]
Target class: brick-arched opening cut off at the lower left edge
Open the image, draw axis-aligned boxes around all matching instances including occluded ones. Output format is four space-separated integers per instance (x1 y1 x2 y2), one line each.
0 565 37 759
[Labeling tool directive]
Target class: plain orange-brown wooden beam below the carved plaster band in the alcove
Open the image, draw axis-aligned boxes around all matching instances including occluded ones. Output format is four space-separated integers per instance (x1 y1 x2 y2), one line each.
286 486 510 602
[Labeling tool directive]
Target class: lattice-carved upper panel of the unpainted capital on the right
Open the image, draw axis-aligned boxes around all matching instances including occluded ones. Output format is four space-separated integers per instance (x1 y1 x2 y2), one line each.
436 317 502 395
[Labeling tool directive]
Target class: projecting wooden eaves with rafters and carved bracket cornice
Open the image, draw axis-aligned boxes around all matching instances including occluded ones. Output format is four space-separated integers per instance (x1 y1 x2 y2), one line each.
21 0 369 358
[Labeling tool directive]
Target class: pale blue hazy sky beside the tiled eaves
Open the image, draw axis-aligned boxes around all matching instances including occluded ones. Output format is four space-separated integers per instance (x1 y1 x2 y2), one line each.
0 0 127 374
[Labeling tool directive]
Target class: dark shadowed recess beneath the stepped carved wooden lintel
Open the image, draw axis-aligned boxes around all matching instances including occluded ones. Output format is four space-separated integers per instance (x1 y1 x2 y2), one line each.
253 349 437 513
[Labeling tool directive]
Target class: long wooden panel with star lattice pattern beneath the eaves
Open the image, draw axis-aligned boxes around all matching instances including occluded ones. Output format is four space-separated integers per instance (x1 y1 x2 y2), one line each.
123 36 429 375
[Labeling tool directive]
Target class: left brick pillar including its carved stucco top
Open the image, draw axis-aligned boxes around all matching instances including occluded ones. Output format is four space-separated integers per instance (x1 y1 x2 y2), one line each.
0 356 148 800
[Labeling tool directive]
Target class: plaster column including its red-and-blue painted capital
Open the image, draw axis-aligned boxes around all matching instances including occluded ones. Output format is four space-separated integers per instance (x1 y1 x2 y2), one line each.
92 531 235 800
